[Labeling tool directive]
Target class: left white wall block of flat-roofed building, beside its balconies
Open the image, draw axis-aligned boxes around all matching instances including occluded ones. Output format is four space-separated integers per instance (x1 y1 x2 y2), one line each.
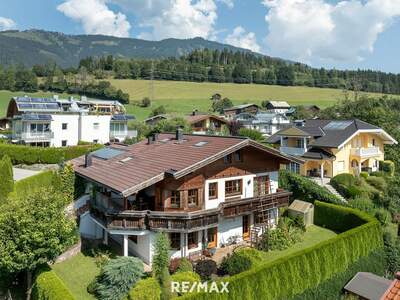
50 114 79 147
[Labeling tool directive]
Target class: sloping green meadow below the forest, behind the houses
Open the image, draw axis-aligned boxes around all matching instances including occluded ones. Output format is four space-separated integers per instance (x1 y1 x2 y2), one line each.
0 79 394 120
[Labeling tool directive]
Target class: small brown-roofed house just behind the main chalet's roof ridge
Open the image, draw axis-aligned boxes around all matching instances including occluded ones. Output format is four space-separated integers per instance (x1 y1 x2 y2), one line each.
185 111 229 134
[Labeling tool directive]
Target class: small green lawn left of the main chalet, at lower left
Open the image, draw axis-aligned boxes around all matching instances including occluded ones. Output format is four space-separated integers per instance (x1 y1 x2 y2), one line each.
52 253 100 300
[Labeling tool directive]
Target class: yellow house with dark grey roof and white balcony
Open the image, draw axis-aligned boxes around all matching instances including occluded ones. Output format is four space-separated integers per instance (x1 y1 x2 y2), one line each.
267 119 397 177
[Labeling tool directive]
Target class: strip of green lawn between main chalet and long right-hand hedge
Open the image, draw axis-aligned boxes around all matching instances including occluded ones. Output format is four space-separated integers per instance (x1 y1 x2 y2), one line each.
241 225 336 264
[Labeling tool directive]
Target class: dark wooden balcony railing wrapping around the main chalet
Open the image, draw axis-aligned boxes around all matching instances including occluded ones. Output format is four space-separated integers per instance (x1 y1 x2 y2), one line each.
90 191 291 232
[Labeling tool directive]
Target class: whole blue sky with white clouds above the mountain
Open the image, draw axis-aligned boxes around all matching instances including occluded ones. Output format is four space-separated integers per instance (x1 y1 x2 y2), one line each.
0 0 400 73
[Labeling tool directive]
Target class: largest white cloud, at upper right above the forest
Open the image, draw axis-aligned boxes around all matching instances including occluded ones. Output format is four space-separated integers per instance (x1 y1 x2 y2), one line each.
263 0 400 62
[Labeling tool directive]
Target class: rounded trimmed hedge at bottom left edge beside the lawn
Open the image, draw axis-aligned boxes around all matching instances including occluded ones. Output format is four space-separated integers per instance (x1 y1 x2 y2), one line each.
32 267 75 300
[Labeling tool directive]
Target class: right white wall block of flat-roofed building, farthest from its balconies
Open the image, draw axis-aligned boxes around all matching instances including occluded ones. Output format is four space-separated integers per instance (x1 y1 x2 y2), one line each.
79 115 111 144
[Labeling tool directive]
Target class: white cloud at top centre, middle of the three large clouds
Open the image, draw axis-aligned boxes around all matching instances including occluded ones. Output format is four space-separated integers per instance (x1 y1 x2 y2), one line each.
112 0 217 40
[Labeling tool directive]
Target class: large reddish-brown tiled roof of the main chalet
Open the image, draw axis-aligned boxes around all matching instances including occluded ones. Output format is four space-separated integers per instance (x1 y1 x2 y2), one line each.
72 134 302 196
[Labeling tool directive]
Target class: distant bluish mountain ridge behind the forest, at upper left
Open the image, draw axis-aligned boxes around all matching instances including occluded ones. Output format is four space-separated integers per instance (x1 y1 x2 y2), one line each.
0 29 262 67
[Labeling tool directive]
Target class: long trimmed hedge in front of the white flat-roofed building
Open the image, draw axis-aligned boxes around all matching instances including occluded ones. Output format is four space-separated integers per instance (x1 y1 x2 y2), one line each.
0 144 103 165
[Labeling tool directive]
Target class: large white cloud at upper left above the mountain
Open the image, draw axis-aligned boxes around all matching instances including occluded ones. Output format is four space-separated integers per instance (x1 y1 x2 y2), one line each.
57 0 131 37
